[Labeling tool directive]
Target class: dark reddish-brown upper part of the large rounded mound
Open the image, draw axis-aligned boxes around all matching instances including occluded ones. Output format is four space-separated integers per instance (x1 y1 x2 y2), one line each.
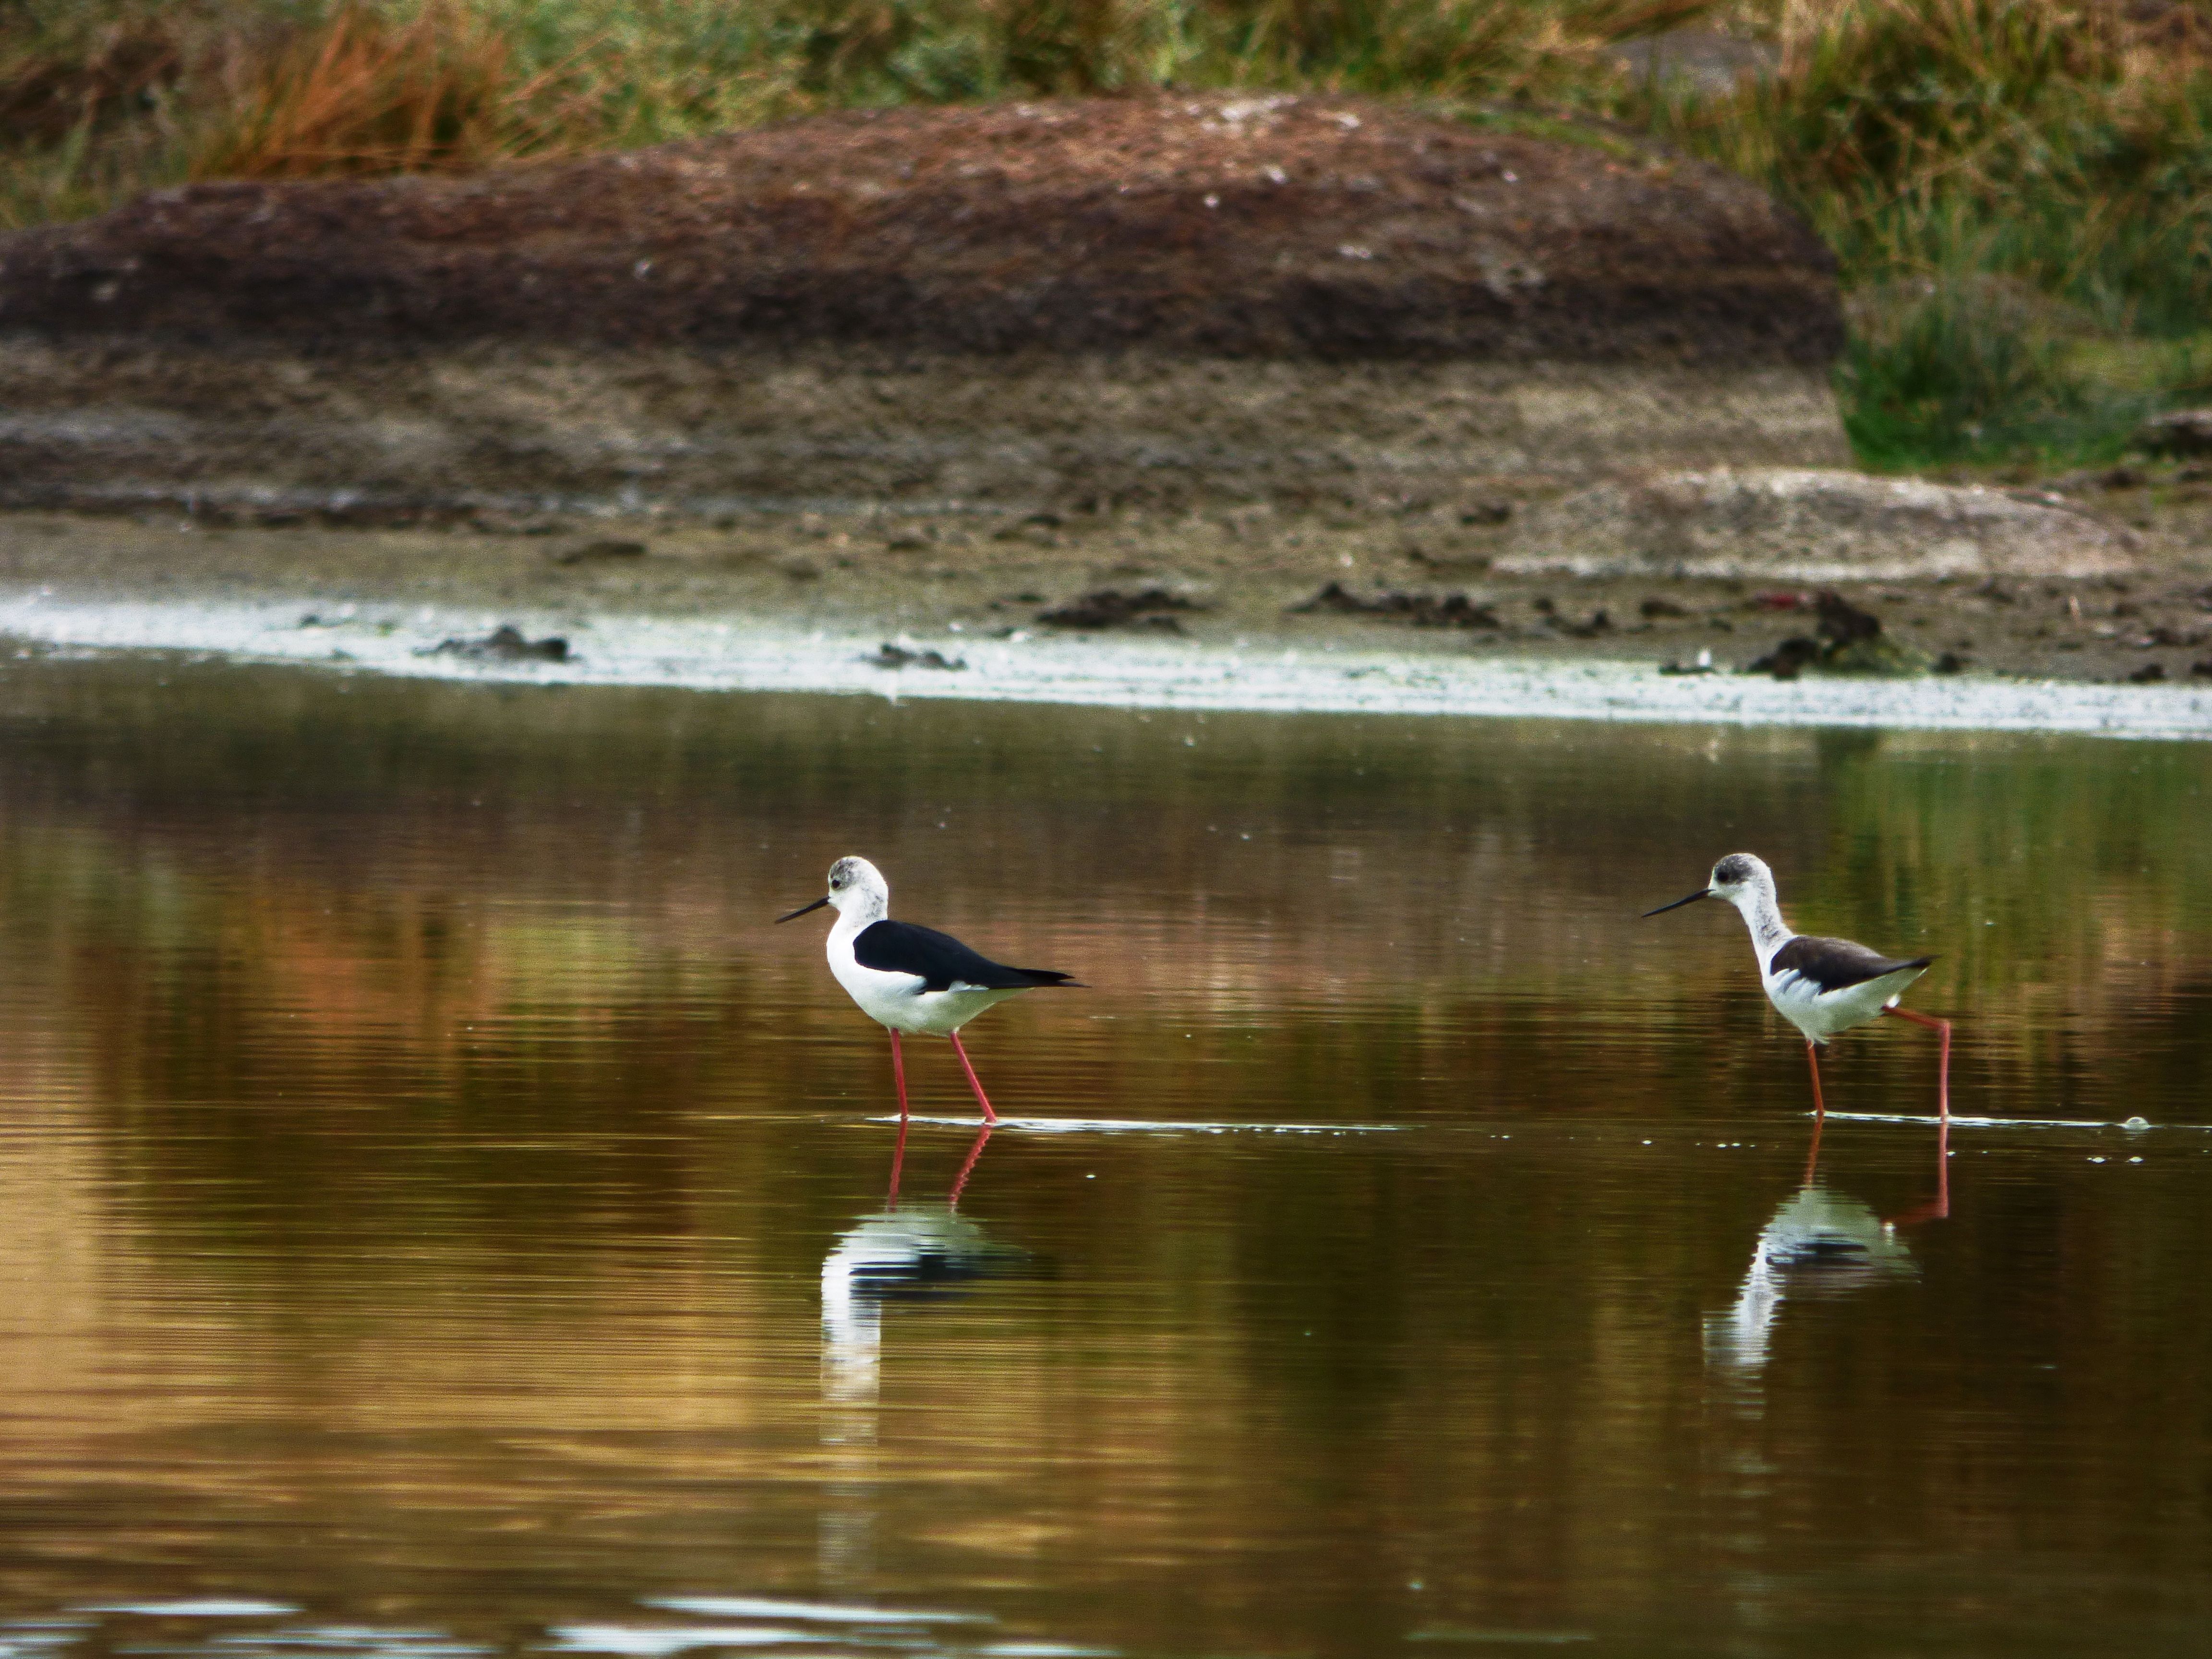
0 95 1842 367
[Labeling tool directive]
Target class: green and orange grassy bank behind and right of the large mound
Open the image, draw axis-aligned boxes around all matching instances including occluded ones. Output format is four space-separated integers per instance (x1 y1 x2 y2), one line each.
0 0 2212 467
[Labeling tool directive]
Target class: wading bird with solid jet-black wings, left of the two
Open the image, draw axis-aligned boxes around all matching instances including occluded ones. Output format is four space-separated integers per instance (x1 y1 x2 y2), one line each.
776 858 1080 1124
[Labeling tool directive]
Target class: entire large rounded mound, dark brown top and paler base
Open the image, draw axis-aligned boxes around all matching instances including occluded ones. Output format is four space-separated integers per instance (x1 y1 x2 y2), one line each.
0 95 1847 517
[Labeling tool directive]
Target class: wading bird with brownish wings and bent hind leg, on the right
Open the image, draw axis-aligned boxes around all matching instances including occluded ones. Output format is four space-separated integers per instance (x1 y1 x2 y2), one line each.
1644 852 1951 1124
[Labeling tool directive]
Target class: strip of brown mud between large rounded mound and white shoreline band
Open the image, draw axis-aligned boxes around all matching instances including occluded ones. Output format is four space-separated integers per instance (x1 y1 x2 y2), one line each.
0 500 2212 685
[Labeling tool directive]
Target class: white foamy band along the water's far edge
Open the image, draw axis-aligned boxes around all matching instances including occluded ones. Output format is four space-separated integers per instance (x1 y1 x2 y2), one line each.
0 593 2212 739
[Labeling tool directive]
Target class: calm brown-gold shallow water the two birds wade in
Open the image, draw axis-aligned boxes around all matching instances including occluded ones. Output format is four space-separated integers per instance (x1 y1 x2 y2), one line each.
0 661 2212 1659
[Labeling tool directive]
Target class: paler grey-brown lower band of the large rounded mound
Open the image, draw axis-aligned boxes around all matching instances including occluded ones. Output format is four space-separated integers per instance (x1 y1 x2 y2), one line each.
0 336 1849 519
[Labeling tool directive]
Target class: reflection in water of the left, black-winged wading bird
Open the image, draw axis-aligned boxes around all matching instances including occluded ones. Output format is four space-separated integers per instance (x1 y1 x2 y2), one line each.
818 1119 1024 1590
